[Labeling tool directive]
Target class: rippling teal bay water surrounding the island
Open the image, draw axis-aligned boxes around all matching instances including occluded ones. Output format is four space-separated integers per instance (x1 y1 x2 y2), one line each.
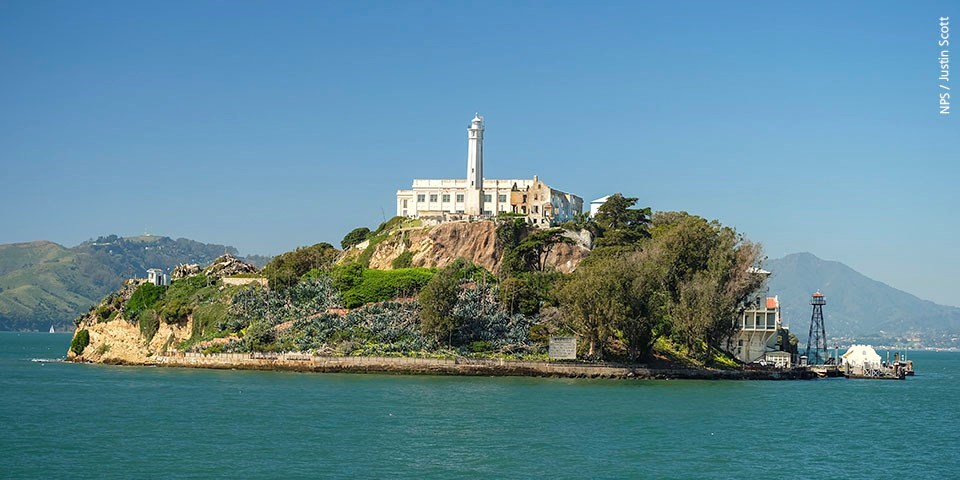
0 333 960 478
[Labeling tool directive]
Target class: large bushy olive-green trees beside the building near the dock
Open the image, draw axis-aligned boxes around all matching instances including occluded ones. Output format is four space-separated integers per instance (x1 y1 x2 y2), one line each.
557 212 762 360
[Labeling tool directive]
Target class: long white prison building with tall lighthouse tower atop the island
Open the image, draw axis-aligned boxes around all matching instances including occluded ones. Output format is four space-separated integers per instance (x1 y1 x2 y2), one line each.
397 114 583 226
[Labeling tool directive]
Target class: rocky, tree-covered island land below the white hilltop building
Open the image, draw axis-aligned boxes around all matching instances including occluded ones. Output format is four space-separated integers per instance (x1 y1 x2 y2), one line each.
68 202 809 379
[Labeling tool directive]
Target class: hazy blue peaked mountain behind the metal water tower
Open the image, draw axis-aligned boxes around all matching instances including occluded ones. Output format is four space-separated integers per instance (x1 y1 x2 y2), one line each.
764 253 960 342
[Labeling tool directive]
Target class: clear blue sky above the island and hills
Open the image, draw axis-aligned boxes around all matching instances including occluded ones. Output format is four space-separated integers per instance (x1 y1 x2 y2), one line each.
0 0 960 305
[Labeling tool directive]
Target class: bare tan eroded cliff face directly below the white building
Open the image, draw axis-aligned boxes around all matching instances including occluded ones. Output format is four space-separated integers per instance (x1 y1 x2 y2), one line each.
360 221 591 273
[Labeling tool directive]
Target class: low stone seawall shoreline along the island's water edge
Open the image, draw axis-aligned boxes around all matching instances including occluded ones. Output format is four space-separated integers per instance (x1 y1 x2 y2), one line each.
67 353 816 380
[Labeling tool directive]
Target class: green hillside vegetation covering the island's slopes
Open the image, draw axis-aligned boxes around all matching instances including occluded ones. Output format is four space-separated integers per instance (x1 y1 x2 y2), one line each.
69 196 762 365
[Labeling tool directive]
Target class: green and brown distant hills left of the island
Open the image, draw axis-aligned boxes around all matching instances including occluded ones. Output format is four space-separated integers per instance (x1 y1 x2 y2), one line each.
0 235 266 330
